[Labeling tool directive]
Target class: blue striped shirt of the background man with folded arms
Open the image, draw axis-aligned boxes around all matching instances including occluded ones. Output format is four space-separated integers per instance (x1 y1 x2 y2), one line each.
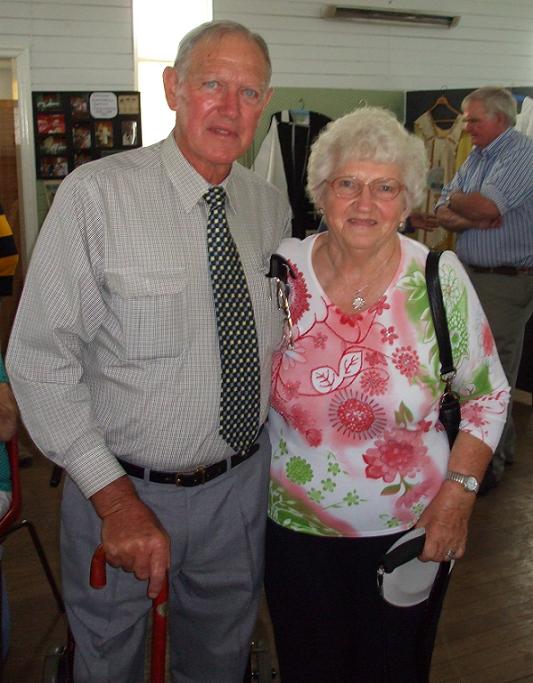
437 128 533 267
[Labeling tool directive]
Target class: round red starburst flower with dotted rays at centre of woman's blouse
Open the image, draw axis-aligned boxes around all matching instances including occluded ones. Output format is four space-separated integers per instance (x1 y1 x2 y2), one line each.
328 389 386 440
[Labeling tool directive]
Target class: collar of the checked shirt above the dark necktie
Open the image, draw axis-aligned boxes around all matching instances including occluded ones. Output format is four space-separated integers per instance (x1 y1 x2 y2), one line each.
161 132 236 213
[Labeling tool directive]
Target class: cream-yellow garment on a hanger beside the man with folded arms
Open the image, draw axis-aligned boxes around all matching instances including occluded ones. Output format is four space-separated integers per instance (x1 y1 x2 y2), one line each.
414 111 463 249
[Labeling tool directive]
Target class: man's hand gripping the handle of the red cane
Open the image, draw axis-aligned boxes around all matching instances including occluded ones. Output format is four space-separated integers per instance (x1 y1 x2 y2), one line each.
91 476 170 598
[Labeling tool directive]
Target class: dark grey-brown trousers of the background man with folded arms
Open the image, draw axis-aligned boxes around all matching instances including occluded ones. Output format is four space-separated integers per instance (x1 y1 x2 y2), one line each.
467 267 533 479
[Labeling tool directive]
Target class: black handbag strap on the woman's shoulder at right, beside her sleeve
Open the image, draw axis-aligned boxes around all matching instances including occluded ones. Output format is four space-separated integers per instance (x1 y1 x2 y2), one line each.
426 251 461 448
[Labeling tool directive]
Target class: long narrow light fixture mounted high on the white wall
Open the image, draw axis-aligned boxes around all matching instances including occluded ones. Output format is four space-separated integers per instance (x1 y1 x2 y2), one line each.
322 5 460 28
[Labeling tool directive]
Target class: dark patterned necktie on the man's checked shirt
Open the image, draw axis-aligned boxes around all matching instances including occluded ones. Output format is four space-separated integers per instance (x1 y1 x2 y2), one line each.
203 187 260 452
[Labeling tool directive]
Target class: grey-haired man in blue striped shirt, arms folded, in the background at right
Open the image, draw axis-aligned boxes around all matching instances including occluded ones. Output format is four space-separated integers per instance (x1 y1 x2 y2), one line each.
436 87 533 493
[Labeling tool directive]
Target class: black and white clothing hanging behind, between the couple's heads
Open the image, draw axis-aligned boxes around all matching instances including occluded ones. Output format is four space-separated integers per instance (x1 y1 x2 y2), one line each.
252 109 331 238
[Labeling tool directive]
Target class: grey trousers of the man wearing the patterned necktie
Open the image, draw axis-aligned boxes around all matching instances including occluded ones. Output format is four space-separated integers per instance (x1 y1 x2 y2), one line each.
61 430 270 683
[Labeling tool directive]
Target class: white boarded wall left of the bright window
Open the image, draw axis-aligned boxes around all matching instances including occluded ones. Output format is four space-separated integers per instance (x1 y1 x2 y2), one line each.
0 0 135 90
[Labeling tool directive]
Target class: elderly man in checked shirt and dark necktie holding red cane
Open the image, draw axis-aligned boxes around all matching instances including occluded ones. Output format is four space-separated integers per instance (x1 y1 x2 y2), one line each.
8 22 290 683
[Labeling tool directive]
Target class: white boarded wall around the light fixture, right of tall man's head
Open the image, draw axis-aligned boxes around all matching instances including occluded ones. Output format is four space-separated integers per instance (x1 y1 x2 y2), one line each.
213 0 533 90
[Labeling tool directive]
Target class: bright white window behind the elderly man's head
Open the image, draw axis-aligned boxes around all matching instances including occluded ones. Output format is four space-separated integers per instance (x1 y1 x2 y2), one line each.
133 0 213 146
